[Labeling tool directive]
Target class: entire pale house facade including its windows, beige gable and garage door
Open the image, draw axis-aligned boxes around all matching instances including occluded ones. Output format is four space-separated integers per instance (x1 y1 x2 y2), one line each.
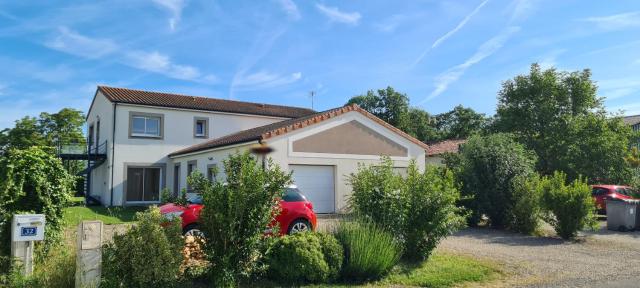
87 90 425 213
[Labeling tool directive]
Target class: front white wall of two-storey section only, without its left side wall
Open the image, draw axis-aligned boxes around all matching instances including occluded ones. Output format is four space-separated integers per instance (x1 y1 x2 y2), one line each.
113 104 283 205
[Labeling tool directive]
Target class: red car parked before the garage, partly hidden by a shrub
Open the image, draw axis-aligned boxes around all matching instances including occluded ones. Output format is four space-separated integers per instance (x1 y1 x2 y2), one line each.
160 186 316 235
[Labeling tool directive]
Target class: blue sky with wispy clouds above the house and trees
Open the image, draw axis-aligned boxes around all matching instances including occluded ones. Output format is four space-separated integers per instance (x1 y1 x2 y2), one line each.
0 0 640 128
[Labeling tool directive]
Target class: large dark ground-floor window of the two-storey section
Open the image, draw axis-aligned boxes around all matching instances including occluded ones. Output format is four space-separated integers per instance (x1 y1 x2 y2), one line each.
127 167 162 202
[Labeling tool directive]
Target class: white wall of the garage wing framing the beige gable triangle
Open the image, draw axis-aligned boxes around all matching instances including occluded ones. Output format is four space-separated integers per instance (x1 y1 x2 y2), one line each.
171 112 425 212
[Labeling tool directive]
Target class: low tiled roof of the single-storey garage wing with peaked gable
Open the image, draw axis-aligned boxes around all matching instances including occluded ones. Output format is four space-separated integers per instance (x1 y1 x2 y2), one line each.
169 104 428 157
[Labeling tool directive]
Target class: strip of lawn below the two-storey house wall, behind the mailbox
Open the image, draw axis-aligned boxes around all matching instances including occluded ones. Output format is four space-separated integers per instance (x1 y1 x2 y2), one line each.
64 206 147 227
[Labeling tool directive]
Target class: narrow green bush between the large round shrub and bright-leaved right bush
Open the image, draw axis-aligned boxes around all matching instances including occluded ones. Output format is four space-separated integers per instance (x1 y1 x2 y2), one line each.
506 173 543 234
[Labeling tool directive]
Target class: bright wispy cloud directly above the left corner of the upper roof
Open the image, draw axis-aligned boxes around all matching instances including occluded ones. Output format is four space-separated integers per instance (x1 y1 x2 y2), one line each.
45 27 118 59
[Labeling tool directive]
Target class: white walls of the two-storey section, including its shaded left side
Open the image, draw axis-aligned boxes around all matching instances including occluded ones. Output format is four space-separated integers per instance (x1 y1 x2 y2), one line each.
87 91 287 206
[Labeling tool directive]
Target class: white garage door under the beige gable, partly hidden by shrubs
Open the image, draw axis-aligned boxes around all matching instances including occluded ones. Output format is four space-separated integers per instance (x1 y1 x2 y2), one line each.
289 165 335 213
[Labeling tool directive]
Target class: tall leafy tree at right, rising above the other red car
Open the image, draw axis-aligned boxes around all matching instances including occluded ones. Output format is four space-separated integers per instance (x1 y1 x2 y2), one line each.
493 64 631 182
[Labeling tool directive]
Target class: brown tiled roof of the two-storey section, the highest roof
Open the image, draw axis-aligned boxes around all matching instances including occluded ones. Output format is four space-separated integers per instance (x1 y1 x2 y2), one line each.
98 86 316 118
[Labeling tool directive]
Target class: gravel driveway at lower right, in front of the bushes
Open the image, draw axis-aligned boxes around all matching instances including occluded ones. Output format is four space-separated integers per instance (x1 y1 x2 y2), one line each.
438 222 640 287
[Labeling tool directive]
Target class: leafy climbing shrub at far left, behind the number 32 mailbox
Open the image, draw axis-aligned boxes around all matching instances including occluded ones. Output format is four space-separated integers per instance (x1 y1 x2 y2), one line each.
0 146 75 256
